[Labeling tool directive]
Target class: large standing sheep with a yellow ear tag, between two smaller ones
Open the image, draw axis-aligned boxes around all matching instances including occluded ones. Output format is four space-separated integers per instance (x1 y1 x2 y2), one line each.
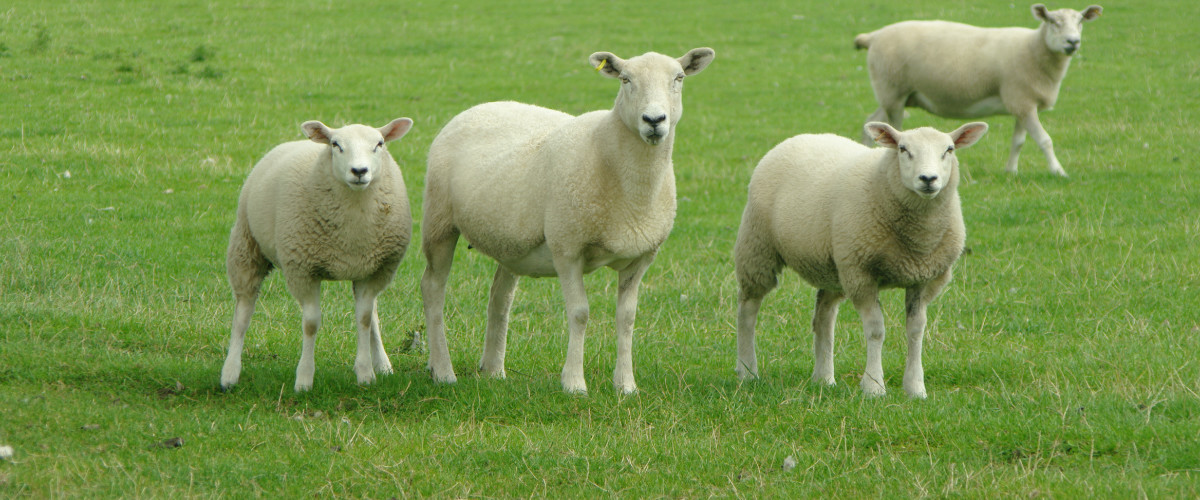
421 48 715 393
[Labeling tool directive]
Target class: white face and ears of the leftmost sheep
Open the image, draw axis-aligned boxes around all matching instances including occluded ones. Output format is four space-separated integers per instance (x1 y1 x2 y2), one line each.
300 118 413 191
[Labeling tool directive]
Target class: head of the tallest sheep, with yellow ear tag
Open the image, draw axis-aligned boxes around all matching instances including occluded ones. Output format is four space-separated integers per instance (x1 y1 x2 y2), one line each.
589 48 715 145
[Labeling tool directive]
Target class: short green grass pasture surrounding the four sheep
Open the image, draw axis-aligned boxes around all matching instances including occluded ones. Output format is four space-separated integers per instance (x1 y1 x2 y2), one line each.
0 0 1200 498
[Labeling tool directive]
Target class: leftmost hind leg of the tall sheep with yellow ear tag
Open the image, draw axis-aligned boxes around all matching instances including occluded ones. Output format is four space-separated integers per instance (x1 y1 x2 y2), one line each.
421 233 458 384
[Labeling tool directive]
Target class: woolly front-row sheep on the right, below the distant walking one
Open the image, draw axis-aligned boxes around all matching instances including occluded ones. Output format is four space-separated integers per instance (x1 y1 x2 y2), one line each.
733 122 988 398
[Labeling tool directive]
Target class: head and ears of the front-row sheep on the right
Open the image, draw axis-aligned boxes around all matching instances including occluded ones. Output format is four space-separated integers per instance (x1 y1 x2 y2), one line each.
865 121 988 199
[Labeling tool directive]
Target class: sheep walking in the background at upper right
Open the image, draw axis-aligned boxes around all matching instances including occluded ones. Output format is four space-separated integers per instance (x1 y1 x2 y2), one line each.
854 4 1102 177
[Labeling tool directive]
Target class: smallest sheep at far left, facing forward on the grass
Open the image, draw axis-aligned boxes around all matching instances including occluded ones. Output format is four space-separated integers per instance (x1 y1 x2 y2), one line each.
221 118 413 392
